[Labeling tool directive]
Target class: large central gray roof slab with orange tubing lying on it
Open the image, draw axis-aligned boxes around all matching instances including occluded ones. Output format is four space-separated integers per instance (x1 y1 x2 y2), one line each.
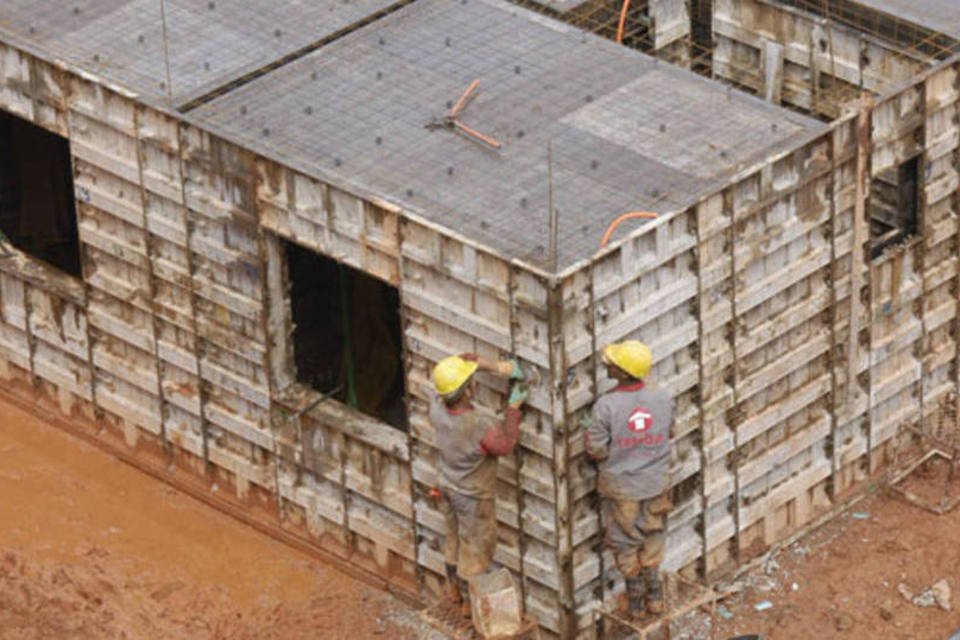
191 0 824 270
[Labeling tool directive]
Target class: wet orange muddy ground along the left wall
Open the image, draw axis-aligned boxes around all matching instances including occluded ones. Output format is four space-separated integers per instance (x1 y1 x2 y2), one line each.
0 401 422 640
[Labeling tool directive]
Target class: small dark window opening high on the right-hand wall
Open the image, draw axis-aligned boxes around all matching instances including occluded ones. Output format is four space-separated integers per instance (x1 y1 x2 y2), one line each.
870 156 920 258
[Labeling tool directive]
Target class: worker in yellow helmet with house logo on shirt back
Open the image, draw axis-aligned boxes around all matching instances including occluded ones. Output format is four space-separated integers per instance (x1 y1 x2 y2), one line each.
585 340 673 617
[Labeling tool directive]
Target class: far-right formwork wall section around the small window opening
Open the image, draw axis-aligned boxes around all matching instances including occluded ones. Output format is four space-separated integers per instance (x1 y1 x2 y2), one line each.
868 63 960 470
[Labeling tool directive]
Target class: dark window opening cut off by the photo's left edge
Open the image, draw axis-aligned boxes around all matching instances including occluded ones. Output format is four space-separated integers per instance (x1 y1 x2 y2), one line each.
0 111 81 278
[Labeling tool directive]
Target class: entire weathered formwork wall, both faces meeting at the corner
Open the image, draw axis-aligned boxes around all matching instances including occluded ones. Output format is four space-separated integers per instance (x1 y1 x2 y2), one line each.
0 25 960 637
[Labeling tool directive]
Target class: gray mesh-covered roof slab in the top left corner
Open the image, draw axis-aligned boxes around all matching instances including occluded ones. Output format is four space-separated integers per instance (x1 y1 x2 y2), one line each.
0 0 396 107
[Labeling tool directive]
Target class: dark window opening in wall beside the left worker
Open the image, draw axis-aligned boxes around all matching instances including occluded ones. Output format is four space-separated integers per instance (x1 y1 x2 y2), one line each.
284 242 407 430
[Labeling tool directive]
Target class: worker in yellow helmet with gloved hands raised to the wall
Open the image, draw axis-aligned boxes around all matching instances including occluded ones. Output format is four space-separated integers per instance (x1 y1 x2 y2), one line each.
430 354 528 617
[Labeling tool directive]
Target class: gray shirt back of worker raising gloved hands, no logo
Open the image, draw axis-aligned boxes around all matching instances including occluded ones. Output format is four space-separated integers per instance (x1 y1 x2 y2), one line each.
430 397 497 498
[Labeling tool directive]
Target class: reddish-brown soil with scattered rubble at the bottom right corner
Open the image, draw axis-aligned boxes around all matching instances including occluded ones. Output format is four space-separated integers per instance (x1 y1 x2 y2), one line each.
716 459 960 640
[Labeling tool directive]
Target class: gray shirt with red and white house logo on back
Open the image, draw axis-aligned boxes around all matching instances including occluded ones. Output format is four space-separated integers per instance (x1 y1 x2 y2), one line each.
586 382 673 500
